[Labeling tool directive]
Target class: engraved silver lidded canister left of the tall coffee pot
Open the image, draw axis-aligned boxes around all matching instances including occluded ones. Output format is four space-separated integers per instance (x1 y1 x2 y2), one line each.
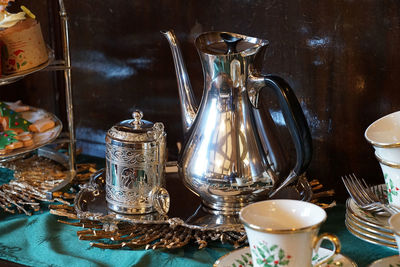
106 110 169 214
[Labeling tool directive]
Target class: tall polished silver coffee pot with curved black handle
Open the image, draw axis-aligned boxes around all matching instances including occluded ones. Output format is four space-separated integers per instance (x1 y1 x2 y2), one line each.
162 30 312 215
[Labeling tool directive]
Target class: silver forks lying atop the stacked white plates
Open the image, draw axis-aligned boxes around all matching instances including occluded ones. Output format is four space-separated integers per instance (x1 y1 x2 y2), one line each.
342 173 399 214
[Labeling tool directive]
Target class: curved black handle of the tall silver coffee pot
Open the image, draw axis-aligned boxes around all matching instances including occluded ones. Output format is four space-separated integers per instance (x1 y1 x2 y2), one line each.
250 75 312 197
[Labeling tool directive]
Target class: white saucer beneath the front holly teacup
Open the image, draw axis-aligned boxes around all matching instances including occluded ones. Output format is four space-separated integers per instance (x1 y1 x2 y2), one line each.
213 247 357 267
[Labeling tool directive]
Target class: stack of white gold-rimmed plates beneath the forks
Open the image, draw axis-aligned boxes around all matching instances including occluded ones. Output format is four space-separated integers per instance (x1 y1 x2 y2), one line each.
345 188 397 249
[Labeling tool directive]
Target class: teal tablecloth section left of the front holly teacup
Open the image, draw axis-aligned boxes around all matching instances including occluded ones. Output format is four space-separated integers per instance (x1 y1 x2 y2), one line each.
0 211 231 267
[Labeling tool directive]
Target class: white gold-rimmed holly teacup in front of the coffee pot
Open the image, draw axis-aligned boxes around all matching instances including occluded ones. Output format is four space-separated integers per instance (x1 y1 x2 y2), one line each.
240 199 340 267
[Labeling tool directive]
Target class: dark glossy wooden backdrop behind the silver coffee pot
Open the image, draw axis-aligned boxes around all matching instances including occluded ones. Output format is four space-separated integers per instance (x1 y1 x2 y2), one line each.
0 0 400 201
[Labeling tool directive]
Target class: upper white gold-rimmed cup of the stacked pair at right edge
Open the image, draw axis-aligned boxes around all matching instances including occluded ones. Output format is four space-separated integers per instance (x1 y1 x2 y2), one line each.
364 111 400 164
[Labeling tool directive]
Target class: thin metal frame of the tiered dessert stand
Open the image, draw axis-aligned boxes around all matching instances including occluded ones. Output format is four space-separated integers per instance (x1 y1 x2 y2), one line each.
0 0 76 198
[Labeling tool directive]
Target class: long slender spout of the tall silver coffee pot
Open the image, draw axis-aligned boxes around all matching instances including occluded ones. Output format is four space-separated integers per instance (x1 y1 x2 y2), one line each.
161 30 198 137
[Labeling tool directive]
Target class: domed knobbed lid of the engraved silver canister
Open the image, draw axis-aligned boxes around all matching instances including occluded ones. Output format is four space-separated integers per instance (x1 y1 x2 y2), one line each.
107 110 164 142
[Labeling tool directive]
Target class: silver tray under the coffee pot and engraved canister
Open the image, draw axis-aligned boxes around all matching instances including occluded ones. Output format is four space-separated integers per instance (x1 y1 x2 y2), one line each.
74 170 312 232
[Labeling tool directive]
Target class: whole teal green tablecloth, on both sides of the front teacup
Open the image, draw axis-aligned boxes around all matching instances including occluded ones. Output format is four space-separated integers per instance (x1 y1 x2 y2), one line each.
0 166 397 267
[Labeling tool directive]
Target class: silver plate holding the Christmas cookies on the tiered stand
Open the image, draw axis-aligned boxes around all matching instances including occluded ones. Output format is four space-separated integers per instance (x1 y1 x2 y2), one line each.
0 102 62 162
